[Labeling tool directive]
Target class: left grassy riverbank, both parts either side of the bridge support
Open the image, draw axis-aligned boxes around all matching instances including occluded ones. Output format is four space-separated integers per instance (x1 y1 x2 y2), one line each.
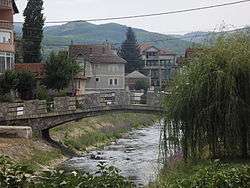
0 113 158 170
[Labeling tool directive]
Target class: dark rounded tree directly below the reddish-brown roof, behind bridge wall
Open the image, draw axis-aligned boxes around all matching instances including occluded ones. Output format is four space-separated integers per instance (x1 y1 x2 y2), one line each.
17 71 36 100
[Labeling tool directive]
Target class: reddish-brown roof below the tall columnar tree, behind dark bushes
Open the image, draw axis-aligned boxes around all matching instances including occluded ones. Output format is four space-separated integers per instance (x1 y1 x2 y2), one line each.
15 63 45 78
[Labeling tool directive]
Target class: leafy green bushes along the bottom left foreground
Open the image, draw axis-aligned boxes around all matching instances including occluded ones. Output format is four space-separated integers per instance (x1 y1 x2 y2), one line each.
0 156 134 188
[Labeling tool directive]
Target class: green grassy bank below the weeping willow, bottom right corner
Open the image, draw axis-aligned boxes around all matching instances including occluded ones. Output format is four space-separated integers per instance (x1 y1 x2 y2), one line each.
149 161 250 188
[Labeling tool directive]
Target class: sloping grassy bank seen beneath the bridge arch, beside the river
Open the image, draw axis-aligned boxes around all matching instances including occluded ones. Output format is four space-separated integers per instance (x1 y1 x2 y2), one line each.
50 113 158 153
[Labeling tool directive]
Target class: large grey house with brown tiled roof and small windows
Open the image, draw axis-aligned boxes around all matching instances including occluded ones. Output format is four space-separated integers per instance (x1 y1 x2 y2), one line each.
69 44 126 92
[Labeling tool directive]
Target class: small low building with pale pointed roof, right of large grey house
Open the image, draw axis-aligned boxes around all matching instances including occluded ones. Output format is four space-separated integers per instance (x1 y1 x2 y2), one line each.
125 71 150 90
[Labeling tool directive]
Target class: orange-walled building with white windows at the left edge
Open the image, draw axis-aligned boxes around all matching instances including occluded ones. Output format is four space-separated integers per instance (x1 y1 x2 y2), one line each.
0 0 18 74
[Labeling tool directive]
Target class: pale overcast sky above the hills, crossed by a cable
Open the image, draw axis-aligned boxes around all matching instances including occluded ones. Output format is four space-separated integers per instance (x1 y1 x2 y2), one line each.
15 0 250 34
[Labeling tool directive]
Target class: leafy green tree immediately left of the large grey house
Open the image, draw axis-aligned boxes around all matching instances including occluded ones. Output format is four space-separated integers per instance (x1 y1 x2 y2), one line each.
44 52 81 92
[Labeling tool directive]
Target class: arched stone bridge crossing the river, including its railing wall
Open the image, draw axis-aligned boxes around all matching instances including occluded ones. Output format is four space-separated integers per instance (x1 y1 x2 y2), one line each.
0 92 163 137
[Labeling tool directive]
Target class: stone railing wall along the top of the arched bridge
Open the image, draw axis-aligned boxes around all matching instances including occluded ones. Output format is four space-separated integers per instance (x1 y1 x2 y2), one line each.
0 91 164 121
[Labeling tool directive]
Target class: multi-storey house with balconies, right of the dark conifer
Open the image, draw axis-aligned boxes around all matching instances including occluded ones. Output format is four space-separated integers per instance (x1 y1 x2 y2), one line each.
139 44 178 88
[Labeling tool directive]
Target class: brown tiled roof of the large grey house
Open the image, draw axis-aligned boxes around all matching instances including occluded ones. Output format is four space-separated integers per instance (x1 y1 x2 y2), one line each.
69 44 127 64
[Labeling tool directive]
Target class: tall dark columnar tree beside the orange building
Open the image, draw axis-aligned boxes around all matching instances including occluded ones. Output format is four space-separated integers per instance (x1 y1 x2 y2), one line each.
23 0 45 63
